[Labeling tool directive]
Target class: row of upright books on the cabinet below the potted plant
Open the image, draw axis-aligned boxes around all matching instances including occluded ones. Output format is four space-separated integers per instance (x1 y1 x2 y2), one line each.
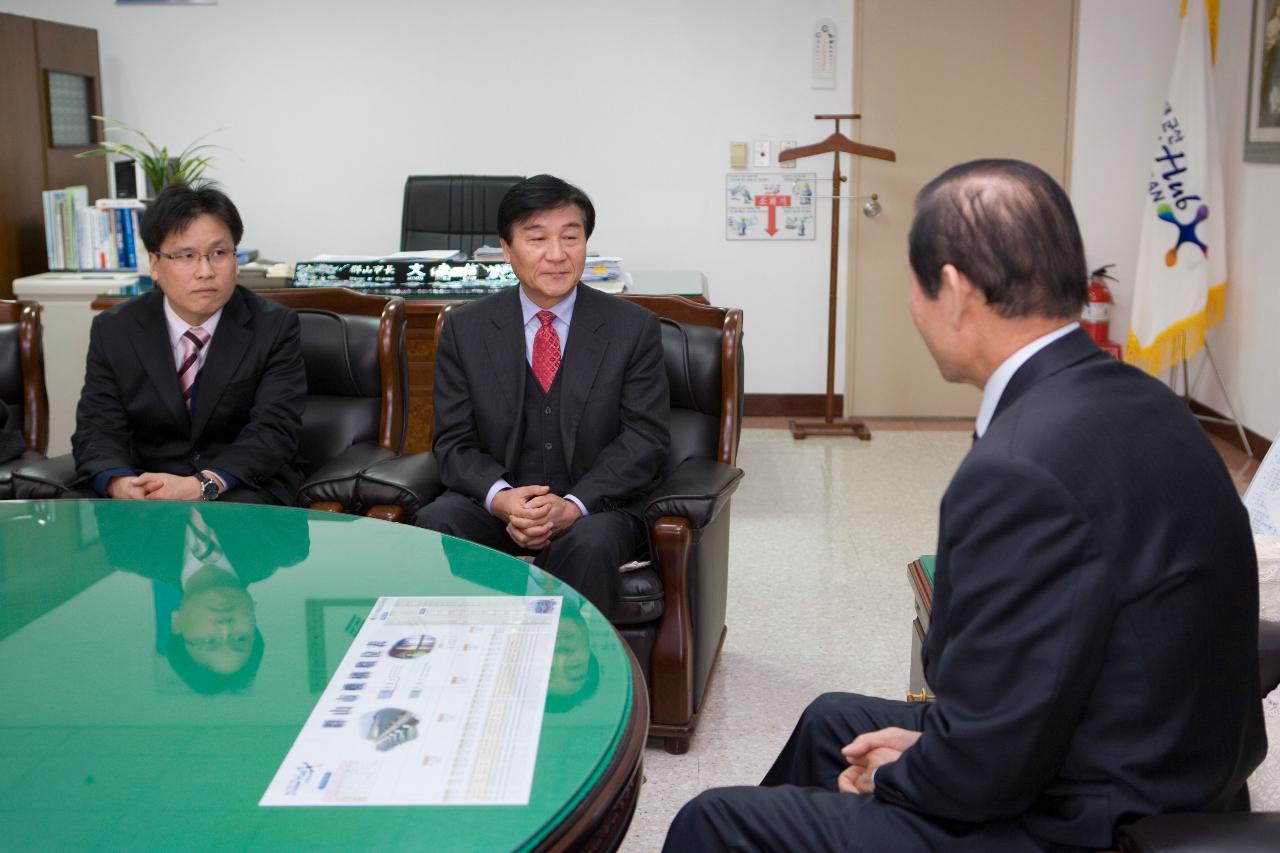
42 186 148 273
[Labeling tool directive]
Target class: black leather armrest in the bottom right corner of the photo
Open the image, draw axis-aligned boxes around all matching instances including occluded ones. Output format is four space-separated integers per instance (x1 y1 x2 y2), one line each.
1120 812 1280 853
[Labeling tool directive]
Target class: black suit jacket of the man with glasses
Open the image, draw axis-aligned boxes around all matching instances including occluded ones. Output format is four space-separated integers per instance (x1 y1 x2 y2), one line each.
72 287 307 503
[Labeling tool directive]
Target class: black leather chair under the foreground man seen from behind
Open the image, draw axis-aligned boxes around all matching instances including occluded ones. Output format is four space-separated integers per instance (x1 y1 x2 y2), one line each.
1120 620 1280 853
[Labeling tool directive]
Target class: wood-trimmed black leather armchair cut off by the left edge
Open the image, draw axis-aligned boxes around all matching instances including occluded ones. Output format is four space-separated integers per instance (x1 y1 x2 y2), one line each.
0 300 49 500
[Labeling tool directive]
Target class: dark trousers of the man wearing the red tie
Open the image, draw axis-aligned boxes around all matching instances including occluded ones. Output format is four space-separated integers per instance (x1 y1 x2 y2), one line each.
413 492 645 616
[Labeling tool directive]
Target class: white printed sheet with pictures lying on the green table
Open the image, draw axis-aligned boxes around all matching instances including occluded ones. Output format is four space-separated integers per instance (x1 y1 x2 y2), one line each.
259 596 562 806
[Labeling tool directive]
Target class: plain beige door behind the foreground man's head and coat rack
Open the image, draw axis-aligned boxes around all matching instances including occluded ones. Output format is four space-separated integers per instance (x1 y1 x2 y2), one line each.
844 0 1075 416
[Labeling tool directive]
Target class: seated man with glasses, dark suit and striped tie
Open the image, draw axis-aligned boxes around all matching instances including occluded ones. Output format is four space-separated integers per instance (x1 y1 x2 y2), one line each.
72 186 306 505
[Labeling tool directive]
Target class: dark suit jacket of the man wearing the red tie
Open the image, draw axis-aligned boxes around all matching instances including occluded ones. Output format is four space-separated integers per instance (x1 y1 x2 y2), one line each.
433 284 671 512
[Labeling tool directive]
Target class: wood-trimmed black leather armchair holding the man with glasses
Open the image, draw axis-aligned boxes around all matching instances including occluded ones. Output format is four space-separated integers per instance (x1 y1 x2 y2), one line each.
13 281 408 511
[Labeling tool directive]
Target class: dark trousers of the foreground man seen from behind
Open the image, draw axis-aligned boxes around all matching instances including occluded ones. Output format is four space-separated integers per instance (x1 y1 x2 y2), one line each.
663 693 1041 853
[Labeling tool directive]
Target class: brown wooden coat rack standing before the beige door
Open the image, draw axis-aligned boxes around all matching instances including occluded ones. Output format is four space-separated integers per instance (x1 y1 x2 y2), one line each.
778 113 897 442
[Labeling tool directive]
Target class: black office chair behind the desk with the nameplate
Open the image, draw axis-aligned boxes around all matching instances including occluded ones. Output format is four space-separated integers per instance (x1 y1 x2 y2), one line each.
401 174 524 255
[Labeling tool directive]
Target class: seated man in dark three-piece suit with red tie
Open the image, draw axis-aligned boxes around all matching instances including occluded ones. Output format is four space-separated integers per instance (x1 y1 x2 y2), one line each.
413 174 671 615
